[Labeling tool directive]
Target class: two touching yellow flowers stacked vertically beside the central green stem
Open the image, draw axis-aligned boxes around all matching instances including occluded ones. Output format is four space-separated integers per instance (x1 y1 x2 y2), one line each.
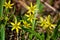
25 2 37 22
